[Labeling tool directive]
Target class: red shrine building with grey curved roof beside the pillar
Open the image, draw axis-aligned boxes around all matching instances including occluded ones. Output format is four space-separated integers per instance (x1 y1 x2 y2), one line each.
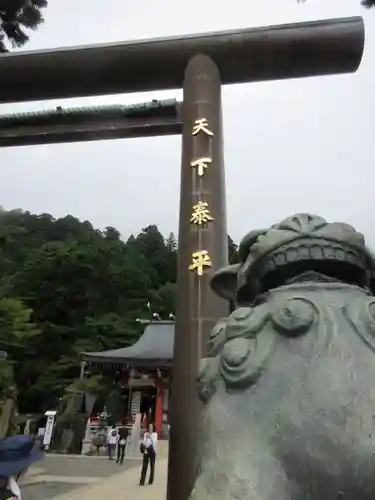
82 320 175 438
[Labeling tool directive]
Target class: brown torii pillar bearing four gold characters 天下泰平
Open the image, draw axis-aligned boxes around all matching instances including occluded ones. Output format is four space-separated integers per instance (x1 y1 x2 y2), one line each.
168 55 229 500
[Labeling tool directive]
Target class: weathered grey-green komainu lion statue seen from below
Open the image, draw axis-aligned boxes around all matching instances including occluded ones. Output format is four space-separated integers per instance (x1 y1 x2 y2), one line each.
190 214 375 500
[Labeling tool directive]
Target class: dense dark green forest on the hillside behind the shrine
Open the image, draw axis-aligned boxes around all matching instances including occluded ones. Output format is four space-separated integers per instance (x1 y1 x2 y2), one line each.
0 210 236 413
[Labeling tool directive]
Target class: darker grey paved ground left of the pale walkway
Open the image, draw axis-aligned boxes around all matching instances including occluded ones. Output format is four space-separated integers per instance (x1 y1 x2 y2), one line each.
21 455 141 500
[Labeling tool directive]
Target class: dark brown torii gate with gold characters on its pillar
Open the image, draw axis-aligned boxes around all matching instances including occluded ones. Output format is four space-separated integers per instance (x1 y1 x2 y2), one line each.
0 17 364 500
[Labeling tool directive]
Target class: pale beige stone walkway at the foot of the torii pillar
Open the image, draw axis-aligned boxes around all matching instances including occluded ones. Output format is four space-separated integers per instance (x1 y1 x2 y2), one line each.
53 459 168 500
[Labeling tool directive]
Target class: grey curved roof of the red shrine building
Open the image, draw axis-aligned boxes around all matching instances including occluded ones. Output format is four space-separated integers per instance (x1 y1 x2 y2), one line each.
82 321 174 366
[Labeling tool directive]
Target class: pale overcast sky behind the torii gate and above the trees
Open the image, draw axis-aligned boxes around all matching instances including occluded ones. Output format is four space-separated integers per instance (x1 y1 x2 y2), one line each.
0 0 375 246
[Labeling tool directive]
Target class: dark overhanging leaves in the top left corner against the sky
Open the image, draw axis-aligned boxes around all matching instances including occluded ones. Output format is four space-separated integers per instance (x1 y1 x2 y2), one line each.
0 0 48 52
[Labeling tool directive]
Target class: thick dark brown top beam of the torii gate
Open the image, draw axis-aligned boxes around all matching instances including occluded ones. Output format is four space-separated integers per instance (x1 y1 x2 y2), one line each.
0 17 364 103
